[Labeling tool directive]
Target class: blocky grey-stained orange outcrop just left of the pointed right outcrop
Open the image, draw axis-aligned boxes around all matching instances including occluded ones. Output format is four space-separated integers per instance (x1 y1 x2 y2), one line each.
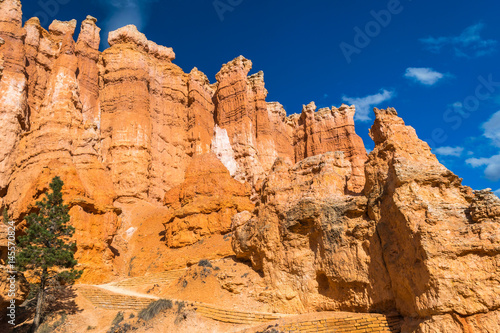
232 152 394 312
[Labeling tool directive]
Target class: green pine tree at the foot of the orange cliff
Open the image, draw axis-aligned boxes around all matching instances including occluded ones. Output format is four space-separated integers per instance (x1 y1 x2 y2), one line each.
16 177 82 332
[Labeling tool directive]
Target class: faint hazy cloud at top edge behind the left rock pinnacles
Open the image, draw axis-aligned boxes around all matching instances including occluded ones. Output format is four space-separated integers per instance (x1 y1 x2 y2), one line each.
99 0 157 46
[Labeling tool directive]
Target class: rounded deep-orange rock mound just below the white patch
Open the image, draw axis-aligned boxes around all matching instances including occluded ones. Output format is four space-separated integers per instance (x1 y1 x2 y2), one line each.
164 154 254 248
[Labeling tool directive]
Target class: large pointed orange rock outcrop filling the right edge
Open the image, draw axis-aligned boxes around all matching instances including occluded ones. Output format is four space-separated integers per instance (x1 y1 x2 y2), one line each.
365 109 500 332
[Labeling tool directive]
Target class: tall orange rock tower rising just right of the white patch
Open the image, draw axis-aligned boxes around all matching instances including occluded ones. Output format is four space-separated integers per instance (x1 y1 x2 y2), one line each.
213 56 293 186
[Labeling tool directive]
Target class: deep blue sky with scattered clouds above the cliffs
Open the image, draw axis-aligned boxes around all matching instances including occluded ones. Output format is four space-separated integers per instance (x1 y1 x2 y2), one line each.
23 0 500 195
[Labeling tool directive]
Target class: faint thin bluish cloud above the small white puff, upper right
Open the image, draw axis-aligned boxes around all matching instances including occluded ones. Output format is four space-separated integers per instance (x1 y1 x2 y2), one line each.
420 22 498 58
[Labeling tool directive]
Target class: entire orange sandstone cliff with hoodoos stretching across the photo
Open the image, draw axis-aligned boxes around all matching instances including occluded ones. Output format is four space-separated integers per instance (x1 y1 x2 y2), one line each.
0 0 500 332
